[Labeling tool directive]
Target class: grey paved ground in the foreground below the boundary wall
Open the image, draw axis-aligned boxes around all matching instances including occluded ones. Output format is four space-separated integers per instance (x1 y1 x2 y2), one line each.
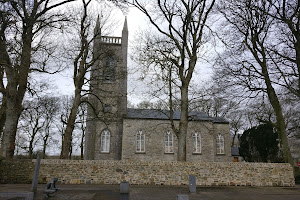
0 184 300 200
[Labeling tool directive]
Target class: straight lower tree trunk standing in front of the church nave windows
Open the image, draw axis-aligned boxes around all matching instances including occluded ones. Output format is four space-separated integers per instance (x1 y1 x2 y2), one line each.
177 83 188 161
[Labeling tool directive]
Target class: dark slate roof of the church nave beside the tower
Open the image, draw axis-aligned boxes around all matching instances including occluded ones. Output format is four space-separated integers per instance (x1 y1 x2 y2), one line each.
125 108 229 124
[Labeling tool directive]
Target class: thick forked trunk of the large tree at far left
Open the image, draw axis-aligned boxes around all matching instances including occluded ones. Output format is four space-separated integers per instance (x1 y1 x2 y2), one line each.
1 23 33 158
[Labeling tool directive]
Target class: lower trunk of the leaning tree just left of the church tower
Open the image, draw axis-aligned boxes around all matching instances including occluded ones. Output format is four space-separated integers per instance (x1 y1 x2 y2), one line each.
60 87 81 159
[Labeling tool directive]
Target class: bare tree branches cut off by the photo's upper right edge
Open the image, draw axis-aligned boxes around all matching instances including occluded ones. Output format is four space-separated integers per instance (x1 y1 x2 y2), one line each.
264 0 300 98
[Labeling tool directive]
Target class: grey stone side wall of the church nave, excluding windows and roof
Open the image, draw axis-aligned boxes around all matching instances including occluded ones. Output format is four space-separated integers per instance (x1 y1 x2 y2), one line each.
122 119 233 162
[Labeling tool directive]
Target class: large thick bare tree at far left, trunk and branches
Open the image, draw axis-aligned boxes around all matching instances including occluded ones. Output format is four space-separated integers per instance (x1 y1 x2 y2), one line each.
0 0 74 158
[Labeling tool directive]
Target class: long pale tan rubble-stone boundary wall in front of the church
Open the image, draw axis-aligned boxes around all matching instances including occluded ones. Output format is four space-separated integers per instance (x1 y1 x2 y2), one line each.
33 160 295 187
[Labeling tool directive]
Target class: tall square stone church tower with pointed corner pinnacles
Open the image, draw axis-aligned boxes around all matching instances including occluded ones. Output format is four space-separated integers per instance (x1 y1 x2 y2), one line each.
84 17 128 160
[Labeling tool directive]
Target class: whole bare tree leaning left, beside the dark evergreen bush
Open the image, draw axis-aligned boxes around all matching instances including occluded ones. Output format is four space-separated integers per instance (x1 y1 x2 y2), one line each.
217 0 294 166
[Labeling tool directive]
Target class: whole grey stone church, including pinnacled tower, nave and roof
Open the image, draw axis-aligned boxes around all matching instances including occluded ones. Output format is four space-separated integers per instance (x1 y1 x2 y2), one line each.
84 19 232 162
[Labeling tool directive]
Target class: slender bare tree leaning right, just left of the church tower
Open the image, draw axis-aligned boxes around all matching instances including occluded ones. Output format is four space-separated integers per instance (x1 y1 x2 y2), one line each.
60 0 127 159
